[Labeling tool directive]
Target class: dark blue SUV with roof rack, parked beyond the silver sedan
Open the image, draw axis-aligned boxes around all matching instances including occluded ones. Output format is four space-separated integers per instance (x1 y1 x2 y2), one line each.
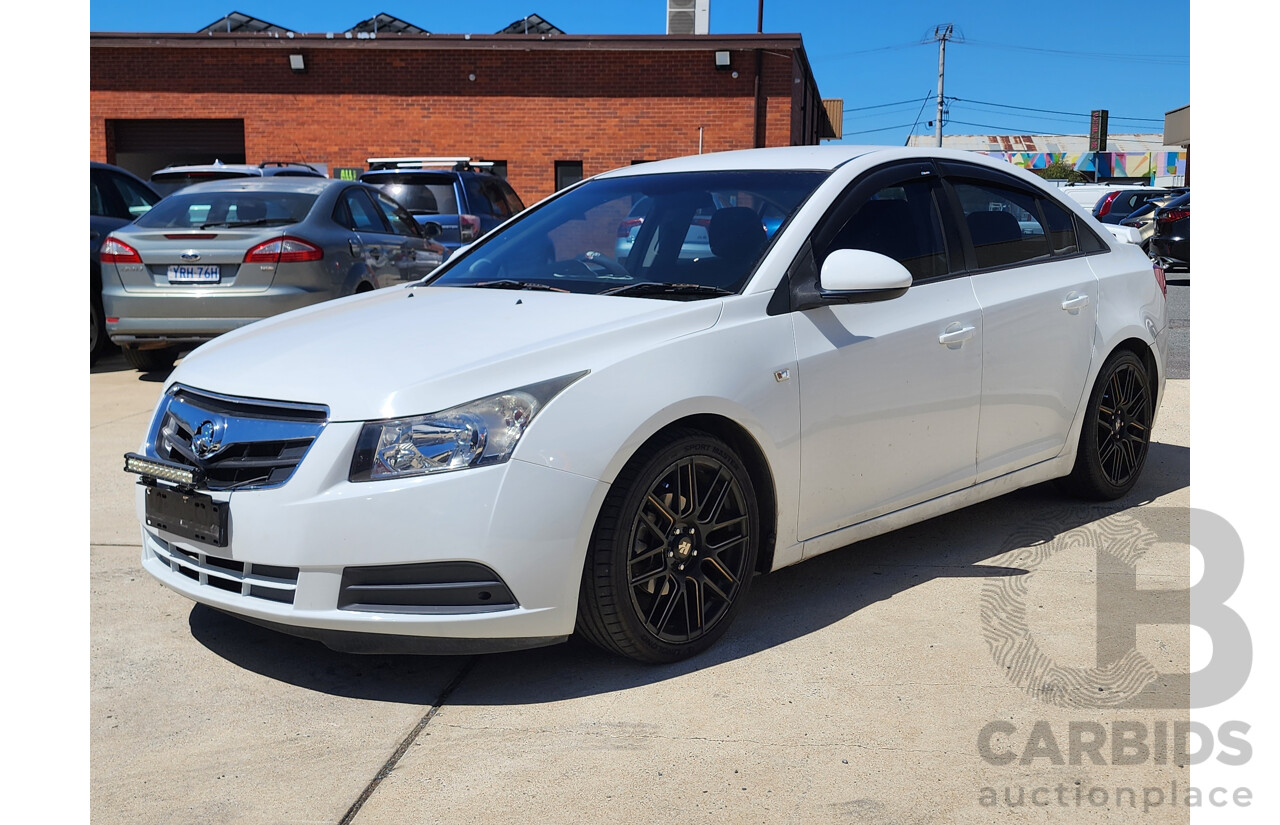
360 157 525 252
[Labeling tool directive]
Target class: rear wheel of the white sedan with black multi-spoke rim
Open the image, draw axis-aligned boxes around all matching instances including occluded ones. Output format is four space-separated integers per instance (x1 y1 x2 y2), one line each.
1064 349 1156 501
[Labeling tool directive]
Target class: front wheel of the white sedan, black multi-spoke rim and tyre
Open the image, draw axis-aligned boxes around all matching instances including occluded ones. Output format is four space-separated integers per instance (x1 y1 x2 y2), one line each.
577 430 760 664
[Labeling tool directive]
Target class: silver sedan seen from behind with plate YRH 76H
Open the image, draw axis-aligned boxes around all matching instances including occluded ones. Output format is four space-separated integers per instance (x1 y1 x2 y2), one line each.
100 177 448 371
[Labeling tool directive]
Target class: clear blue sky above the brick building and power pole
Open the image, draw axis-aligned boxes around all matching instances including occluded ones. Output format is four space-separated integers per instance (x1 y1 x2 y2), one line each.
88 0 1190 145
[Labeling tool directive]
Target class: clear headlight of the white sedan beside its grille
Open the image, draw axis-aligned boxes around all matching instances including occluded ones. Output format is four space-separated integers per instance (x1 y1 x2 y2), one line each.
348 371 586 481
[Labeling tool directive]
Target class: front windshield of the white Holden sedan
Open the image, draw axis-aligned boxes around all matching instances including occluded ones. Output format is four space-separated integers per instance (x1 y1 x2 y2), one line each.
431 171 829 298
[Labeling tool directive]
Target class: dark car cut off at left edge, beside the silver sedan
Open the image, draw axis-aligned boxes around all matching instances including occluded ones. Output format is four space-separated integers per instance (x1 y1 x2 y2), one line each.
88 161 160 365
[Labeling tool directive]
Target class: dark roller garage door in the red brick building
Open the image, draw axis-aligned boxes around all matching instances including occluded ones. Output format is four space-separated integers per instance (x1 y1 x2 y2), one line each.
106 118 244 179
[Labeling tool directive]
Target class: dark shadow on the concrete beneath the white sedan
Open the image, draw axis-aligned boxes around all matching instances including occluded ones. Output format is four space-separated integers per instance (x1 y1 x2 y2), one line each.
189 444 1190 705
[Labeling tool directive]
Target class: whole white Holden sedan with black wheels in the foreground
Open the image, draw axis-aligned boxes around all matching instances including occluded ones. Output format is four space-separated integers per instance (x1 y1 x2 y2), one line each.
125 146 1167 661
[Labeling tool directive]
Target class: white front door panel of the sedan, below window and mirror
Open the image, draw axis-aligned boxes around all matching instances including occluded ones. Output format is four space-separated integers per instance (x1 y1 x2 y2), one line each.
791 278 983 538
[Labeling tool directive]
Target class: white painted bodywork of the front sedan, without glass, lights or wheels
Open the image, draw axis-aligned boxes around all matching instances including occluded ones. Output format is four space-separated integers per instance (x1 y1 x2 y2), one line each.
137 146 1167 652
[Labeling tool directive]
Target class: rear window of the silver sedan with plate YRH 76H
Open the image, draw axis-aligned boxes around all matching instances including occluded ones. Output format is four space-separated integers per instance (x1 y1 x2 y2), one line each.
137 191 316 229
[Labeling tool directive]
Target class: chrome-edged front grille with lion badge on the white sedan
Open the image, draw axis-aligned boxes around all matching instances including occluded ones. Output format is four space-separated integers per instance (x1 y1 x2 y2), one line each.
148 385 329 490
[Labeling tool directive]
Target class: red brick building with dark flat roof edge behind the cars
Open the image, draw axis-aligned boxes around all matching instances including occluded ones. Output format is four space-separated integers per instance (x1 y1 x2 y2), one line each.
90 31 838 203
